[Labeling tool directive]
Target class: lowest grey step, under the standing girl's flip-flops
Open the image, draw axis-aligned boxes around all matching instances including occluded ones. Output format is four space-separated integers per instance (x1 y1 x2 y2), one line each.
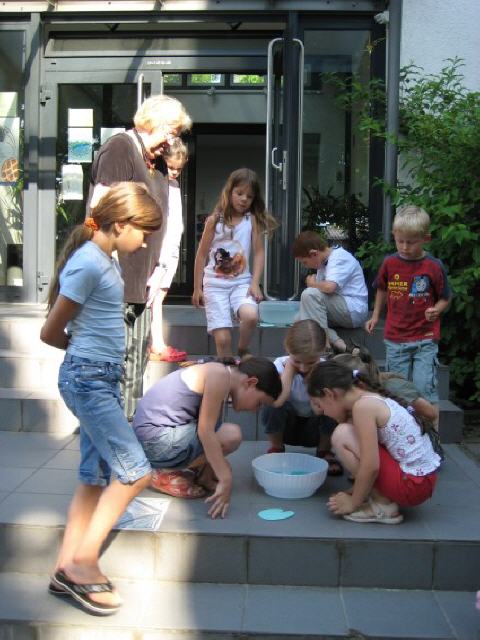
0 574 479 640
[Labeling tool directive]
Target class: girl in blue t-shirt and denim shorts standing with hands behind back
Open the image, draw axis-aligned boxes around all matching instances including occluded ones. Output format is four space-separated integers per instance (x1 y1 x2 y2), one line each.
40 182 162 615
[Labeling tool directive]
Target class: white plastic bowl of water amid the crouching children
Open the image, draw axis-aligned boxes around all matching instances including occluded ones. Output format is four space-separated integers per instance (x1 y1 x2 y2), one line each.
252 453 328 498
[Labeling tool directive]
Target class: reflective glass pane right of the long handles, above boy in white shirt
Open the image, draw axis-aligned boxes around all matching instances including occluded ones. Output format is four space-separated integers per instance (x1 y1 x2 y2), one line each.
302 29 372 251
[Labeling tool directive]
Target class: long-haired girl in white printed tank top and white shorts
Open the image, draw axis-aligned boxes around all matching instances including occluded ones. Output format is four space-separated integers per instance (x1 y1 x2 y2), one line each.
192 169 276 357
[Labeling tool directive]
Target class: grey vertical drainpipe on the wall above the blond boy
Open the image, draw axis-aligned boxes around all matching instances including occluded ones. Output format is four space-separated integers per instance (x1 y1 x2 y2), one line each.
382 0 402 241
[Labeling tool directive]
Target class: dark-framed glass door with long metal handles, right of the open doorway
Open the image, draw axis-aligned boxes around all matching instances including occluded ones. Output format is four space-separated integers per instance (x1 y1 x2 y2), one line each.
264 19 385 299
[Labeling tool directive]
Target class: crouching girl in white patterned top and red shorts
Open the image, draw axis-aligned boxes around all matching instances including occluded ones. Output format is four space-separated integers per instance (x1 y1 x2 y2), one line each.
308 360 441 524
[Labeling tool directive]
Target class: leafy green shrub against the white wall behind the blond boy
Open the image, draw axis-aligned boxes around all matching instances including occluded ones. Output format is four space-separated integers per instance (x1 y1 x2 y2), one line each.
326 59 480 403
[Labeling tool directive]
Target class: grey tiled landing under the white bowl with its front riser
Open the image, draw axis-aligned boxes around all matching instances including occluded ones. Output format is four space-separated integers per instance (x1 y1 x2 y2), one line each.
0 432 480 601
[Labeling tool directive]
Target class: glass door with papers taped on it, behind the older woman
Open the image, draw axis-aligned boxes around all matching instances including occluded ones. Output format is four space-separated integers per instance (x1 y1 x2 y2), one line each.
37 71 161 300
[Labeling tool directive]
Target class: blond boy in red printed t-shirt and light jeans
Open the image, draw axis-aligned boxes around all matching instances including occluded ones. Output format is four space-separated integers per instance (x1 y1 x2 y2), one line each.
365 205 452 424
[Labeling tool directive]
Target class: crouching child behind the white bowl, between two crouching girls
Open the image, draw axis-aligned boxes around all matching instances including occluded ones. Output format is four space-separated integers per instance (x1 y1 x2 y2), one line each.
260 320 342 476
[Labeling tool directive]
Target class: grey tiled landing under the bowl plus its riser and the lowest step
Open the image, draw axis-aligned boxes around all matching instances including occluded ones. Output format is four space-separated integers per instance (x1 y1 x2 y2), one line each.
0 432 480 640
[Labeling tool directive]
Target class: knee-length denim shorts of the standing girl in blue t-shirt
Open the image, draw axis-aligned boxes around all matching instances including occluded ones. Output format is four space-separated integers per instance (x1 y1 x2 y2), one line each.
58 353 151 486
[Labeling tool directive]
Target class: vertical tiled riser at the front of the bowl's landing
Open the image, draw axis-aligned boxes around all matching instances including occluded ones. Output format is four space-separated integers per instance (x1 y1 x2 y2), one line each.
0 524 480 592
